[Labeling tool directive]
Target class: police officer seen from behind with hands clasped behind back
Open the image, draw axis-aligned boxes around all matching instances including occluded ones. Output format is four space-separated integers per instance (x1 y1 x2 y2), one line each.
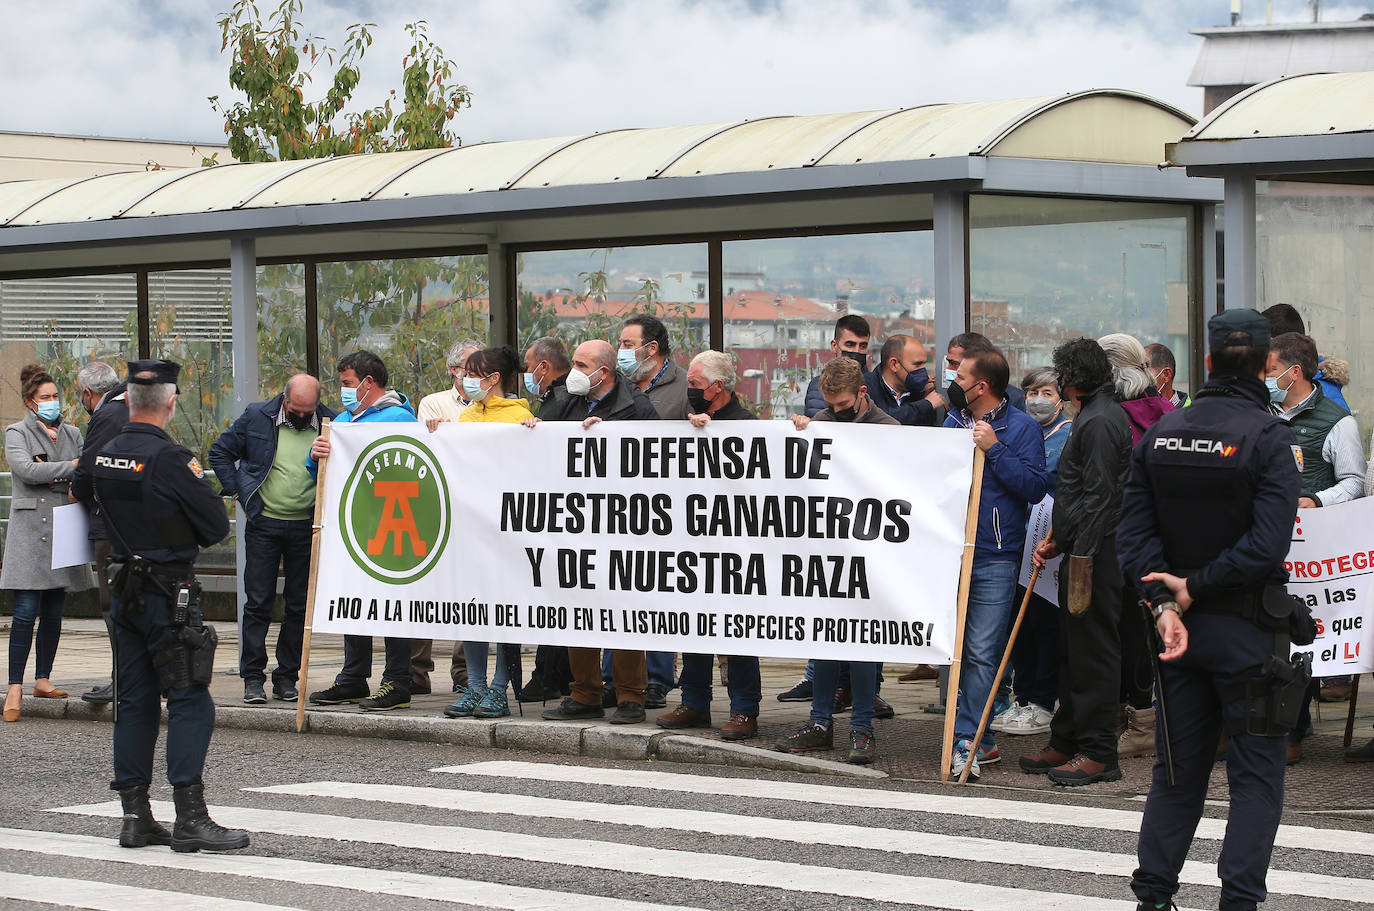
1118 309 1311 911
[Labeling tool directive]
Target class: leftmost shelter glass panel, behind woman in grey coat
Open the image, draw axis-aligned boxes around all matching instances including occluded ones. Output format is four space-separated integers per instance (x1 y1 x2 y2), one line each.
0 275 137 535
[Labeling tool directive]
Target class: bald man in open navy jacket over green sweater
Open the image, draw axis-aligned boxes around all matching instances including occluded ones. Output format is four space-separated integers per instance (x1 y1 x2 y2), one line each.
210 374 335 705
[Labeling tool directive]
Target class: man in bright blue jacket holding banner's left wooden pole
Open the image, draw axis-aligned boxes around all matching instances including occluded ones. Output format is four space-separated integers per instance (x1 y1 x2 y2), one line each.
305 350 415 712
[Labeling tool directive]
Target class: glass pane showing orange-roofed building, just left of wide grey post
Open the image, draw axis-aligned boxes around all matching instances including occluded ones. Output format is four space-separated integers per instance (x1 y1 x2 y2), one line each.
723 231 934 418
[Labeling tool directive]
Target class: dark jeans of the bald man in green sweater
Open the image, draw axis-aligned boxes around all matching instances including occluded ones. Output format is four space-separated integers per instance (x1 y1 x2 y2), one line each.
239 515 311 684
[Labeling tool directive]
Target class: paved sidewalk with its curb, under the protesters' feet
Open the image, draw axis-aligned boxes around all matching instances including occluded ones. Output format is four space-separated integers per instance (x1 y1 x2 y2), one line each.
10 618 1374 812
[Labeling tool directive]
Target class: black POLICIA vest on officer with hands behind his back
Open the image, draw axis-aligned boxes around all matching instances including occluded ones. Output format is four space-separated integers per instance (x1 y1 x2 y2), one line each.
1142 398 1278 576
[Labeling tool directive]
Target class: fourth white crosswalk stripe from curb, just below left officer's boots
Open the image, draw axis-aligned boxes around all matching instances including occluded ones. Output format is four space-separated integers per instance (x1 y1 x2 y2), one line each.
0 824 697 911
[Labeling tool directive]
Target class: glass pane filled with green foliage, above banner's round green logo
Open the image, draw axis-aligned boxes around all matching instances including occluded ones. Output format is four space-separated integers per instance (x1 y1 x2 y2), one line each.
317 256 491 405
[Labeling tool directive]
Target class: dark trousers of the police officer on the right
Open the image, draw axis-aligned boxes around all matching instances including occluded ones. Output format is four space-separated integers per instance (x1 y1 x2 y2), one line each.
1131 610 1287 911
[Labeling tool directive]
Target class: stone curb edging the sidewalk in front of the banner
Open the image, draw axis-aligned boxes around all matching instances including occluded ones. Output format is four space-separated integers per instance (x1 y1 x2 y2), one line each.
37 697 888 780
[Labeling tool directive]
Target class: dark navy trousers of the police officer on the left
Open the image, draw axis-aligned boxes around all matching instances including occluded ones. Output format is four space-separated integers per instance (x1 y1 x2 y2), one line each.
110 591 214 790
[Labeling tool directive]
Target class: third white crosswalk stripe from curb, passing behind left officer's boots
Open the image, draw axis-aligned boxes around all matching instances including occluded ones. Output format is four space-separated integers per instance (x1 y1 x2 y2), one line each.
52 801 1192 911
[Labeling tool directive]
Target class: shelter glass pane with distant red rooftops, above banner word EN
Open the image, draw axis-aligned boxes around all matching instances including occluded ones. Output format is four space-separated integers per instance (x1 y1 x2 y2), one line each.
517 243 710 367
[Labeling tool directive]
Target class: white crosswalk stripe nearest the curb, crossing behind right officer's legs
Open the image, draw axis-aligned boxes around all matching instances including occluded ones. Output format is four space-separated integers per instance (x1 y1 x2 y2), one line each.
430 760 1374 856
